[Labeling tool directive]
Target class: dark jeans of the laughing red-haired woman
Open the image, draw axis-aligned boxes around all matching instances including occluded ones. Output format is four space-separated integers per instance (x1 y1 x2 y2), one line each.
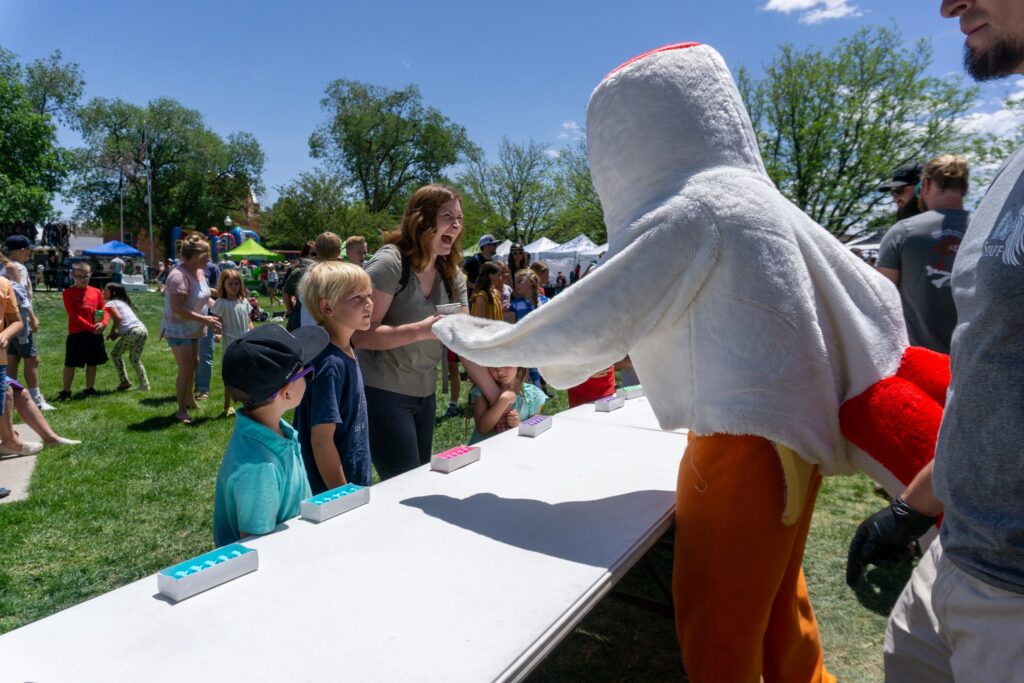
365 386 437 481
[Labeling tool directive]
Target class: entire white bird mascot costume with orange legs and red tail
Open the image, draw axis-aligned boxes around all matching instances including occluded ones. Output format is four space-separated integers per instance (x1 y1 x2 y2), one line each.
433 43 949 682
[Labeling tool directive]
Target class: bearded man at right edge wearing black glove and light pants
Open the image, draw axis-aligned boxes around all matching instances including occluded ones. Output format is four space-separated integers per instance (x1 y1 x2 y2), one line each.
858 0 1024 683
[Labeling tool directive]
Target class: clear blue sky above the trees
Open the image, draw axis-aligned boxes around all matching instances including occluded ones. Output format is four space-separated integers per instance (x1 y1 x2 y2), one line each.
0 0 1021 216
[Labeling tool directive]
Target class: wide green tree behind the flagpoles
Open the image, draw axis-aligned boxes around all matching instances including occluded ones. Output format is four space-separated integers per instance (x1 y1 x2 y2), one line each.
71 97 264 242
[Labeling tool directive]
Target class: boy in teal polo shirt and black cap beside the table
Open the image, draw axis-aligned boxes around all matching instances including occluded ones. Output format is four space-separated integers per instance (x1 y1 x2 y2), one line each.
213 325 329 547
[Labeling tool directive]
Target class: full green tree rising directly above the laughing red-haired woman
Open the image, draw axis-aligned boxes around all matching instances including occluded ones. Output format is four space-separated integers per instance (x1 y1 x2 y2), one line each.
309 80 475 214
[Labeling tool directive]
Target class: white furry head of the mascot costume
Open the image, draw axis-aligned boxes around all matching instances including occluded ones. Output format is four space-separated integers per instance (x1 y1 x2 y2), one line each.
587 43 767 243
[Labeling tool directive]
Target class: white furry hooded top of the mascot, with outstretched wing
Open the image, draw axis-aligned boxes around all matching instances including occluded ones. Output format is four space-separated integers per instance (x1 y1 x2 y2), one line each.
433 45 907 474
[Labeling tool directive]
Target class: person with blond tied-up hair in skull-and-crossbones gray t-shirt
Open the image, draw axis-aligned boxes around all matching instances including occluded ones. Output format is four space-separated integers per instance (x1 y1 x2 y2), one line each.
878 155 968 353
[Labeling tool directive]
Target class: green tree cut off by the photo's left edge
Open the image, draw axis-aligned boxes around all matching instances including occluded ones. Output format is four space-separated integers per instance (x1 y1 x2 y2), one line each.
0 78 67 223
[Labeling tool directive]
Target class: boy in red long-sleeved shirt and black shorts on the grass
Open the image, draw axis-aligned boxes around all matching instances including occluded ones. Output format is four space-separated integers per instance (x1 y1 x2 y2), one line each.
57 261 110 400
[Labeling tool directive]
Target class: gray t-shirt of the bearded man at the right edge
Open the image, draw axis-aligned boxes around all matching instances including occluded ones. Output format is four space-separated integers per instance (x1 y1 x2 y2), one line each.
934 147 1024 593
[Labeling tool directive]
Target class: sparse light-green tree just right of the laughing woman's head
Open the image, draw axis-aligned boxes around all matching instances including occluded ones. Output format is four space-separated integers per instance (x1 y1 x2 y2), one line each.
459 137 559 245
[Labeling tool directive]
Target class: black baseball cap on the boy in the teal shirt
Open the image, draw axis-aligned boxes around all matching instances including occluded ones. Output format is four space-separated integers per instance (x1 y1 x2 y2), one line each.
220 323 331 403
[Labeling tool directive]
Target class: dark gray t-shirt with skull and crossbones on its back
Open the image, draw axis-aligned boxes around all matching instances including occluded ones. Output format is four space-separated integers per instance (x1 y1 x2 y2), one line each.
879 209 969 353
